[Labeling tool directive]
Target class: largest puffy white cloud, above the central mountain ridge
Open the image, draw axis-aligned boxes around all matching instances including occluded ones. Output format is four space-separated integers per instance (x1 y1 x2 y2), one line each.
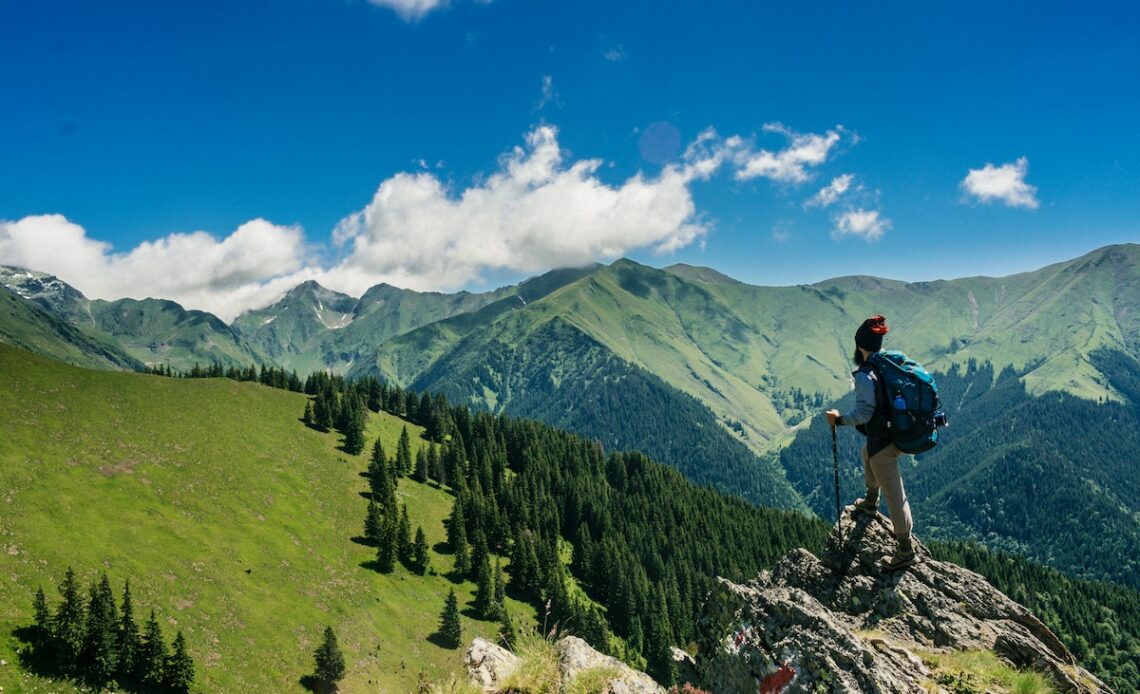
321 125 724 293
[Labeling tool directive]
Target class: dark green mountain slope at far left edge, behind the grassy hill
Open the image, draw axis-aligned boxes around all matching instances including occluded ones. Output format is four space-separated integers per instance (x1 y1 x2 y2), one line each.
0 286 144 370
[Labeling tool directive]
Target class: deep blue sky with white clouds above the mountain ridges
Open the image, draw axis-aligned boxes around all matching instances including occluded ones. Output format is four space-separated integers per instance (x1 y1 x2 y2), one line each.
0 0 1140 317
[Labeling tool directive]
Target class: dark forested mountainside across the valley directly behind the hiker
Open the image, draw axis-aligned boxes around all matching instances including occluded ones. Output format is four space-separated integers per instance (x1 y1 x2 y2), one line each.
780 353 1140 589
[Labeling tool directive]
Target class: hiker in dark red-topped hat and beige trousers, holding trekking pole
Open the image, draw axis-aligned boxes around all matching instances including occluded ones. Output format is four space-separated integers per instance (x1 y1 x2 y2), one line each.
827 316 918 571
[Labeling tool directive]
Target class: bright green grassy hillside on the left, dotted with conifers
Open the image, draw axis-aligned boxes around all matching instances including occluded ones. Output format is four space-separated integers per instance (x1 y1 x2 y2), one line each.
0 346 527 692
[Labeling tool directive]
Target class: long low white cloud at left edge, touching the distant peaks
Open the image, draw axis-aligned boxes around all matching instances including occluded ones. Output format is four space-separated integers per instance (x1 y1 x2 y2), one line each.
0 214 316 320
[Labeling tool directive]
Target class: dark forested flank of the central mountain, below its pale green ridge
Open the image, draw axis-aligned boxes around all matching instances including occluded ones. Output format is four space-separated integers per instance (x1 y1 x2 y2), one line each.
413 319 801 508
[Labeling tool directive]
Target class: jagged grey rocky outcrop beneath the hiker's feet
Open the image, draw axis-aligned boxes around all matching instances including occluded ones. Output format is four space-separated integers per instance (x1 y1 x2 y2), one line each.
694 507 1110 694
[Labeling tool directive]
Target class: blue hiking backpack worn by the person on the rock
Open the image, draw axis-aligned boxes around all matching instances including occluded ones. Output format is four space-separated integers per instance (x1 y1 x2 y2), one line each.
868 351 947 454
